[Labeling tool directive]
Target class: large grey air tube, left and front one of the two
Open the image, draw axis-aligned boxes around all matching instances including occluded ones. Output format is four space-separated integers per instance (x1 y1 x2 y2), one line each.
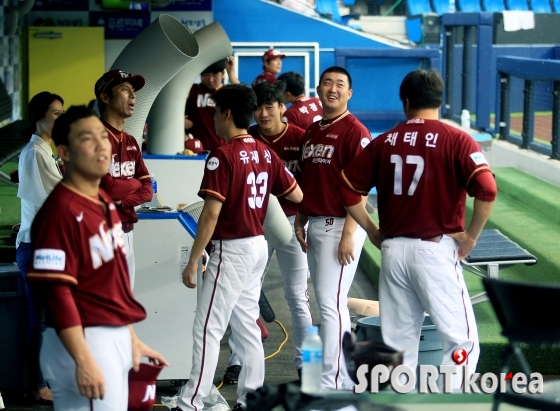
111 14 199 146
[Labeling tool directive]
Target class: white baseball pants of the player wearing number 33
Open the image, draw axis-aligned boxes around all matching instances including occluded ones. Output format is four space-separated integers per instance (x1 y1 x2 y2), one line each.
177 236 267 411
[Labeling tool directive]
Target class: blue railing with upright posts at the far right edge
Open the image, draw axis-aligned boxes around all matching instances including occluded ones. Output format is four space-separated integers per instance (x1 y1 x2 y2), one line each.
495 57 560 159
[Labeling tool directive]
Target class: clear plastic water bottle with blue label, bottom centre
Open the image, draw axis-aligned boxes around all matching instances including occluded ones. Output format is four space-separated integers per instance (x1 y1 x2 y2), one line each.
301 325 323 393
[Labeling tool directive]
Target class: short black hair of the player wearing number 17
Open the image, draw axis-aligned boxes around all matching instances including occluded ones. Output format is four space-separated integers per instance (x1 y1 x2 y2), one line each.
399 70 443 110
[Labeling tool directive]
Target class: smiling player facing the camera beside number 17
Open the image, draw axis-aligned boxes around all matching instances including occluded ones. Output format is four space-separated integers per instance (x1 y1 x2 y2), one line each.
294 66 371 390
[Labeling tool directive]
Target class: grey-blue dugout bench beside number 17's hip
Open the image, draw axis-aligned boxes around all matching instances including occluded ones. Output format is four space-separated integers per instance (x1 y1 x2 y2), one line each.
461 228 537 305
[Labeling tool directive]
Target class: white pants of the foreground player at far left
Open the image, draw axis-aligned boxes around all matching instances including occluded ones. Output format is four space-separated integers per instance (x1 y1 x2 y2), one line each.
41 326 132 411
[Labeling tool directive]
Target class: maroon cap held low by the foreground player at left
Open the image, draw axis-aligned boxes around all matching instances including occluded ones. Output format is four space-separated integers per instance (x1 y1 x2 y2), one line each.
128 363 164 411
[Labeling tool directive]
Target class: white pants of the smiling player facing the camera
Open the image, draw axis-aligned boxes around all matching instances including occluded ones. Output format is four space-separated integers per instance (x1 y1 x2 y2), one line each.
307 217 366 390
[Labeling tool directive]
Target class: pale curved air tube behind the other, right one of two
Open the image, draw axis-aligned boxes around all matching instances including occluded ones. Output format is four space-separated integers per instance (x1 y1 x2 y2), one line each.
148 23 232 154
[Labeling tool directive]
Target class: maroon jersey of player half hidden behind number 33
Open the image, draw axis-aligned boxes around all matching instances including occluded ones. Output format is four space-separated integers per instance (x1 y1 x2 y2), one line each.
247 124 305 217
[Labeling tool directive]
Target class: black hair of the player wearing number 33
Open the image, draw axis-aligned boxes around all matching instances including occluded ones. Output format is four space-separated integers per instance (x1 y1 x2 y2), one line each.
212 84 257 129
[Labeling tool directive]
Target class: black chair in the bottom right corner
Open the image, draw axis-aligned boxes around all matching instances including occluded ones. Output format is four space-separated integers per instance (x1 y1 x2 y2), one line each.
482 278 560 411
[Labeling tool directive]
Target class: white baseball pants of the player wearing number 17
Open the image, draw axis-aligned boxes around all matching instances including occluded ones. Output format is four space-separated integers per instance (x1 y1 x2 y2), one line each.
379 235 480 390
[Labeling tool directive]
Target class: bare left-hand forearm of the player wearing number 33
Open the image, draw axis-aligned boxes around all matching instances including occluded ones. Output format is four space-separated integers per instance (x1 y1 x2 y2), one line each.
183 195 223 288
